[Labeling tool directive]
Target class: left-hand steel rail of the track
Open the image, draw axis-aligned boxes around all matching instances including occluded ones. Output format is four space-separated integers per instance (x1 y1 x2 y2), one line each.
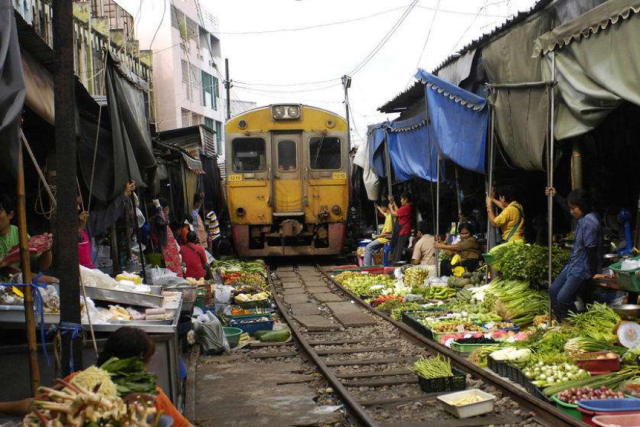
268 273 380 427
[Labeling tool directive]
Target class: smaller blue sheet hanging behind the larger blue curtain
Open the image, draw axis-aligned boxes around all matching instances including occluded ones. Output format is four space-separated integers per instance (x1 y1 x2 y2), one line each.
387 112 443 182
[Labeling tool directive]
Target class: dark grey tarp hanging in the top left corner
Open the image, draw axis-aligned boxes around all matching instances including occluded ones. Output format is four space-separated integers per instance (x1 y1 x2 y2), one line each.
0 0 25 174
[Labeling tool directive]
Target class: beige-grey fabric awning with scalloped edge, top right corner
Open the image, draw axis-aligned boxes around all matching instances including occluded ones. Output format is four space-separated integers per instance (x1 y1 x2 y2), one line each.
534 0 640 140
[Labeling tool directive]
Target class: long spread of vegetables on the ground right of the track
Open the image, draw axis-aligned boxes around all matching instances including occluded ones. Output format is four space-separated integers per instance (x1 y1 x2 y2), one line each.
331 244 640 425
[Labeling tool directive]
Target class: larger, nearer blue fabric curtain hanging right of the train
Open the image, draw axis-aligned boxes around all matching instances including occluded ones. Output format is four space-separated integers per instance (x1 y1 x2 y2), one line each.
416 70 489 173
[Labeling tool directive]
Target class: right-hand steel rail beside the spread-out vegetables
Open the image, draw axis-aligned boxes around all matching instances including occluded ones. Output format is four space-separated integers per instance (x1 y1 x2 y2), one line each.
316 264 587 427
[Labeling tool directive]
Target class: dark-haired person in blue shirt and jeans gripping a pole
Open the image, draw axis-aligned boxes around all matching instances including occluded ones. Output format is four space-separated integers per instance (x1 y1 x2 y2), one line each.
546 187 602 322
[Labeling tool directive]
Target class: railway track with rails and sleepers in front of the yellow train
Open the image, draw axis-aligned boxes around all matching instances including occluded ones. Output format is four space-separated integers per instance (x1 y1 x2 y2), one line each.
270 265 584 427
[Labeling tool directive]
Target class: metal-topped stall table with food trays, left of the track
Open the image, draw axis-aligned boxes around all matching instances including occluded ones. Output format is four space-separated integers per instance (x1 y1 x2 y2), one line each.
0 267 188 406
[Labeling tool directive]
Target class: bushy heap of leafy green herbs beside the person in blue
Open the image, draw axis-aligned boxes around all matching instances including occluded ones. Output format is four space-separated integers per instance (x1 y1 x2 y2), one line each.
491 243 569 287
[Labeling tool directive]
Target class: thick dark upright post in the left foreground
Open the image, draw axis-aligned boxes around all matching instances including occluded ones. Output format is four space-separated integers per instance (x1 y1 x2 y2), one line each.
53 1 83 377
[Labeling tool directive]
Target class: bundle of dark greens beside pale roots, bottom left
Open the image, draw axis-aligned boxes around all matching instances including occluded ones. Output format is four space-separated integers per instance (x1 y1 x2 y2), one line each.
100 357 157 397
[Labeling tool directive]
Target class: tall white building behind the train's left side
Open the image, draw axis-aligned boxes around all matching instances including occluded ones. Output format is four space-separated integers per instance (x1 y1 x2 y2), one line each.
137 0 226 155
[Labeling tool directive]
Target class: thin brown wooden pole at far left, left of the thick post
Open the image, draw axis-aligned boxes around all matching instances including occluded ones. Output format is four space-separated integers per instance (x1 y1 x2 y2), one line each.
17 139 40 397
